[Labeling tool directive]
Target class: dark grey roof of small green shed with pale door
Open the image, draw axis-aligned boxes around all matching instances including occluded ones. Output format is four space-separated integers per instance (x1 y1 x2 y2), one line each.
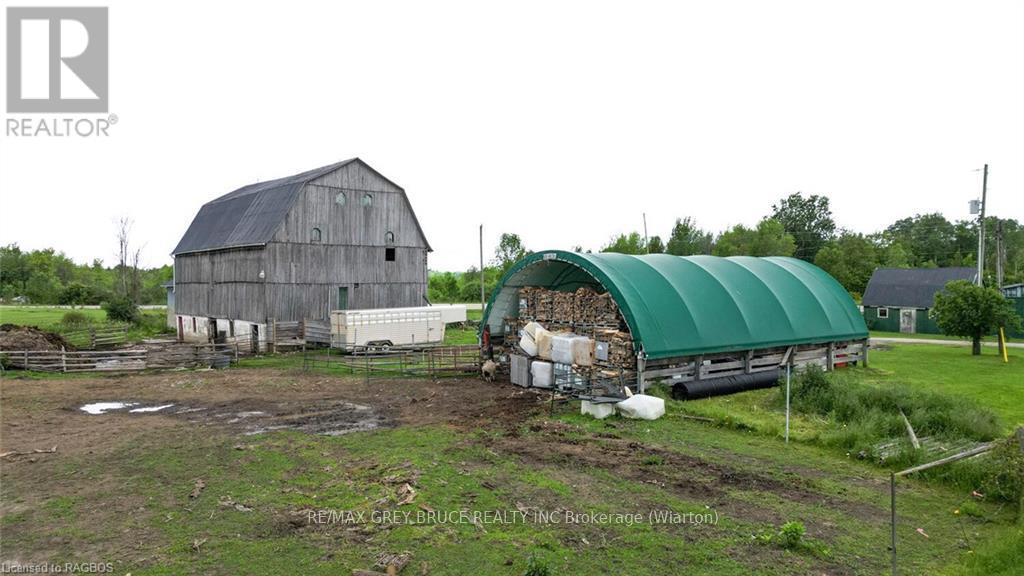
861 268 978 308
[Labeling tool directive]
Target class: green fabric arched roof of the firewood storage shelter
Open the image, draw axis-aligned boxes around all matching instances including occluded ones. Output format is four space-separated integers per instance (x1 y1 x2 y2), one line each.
484 250 867 359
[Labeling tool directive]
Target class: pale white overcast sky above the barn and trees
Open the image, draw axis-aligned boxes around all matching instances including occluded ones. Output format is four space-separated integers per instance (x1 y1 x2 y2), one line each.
0 0 1024 270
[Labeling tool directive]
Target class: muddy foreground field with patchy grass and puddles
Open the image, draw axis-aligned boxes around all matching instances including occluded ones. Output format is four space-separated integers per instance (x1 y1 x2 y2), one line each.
0 369 1007 574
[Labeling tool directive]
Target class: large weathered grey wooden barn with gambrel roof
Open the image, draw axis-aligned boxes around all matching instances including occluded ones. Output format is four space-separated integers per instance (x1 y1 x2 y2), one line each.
173 158 431 339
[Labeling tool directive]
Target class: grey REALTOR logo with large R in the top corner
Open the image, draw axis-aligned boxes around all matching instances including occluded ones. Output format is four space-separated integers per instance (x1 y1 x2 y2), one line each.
6 6 117 136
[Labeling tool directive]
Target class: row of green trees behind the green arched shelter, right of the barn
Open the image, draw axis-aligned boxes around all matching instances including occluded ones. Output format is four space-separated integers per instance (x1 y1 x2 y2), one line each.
429 193 1024 302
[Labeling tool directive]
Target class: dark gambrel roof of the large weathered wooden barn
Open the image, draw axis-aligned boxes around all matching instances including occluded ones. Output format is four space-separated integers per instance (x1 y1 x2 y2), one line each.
171 158 431 256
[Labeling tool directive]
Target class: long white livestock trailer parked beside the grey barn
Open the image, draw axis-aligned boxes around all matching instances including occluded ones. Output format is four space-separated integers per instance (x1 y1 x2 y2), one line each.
331 306 448 349
